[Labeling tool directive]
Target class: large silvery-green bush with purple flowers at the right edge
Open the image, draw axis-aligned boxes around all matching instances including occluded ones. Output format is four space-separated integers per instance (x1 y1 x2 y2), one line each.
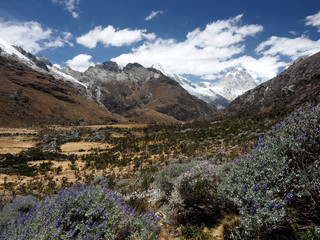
218 105 320 239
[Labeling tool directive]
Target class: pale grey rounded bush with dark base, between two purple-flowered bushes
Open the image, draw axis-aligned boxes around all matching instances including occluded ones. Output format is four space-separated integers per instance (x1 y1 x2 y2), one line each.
169 161 220 226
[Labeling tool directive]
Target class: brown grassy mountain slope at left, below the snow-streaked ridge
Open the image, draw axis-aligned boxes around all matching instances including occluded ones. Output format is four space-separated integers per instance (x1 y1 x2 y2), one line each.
0 55 120 127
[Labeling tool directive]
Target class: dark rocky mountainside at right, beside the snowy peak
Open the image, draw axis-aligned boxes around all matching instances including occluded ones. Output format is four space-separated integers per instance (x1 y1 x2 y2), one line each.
225 53 320 115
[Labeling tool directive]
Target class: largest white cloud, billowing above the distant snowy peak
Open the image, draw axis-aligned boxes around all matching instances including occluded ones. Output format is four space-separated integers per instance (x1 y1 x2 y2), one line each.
112 15 263 79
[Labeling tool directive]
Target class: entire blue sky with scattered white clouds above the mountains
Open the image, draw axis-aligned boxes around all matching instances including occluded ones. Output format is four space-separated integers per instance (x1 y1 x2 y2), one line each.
0 0 320 81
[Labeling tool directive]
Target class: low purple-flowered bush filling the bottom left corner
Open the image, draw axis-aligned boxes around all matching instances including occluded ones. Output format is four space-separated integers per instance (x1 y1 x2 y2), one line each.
0 182 159 240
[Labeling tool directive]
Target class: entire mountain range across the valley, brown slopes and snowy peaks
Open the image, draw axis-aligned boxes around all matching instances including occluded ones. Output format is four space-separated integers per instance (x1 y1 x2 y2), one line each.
0 36 320 126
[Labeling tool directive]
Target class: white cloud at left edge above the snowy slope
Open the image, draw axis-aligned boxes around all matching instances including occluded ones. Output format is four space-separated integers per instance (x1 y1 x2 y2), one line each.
0 18 73 54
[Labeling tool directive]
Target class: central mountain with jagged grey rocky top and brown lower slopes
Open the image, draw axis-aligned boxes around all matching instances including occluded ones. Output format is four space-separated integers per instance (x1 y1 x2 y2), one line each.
61 62 217 123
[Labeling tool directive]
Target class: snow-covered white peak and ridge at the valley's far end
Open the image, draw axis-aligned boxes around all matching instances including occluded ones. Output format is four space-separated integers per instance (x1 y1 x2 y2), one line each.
152 63 260 109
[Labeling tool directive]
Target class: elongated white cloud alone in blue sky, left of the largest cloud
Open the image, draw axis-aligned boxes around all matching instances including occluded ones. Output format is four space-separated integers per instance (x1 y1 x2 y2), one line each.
77 25 156 48
